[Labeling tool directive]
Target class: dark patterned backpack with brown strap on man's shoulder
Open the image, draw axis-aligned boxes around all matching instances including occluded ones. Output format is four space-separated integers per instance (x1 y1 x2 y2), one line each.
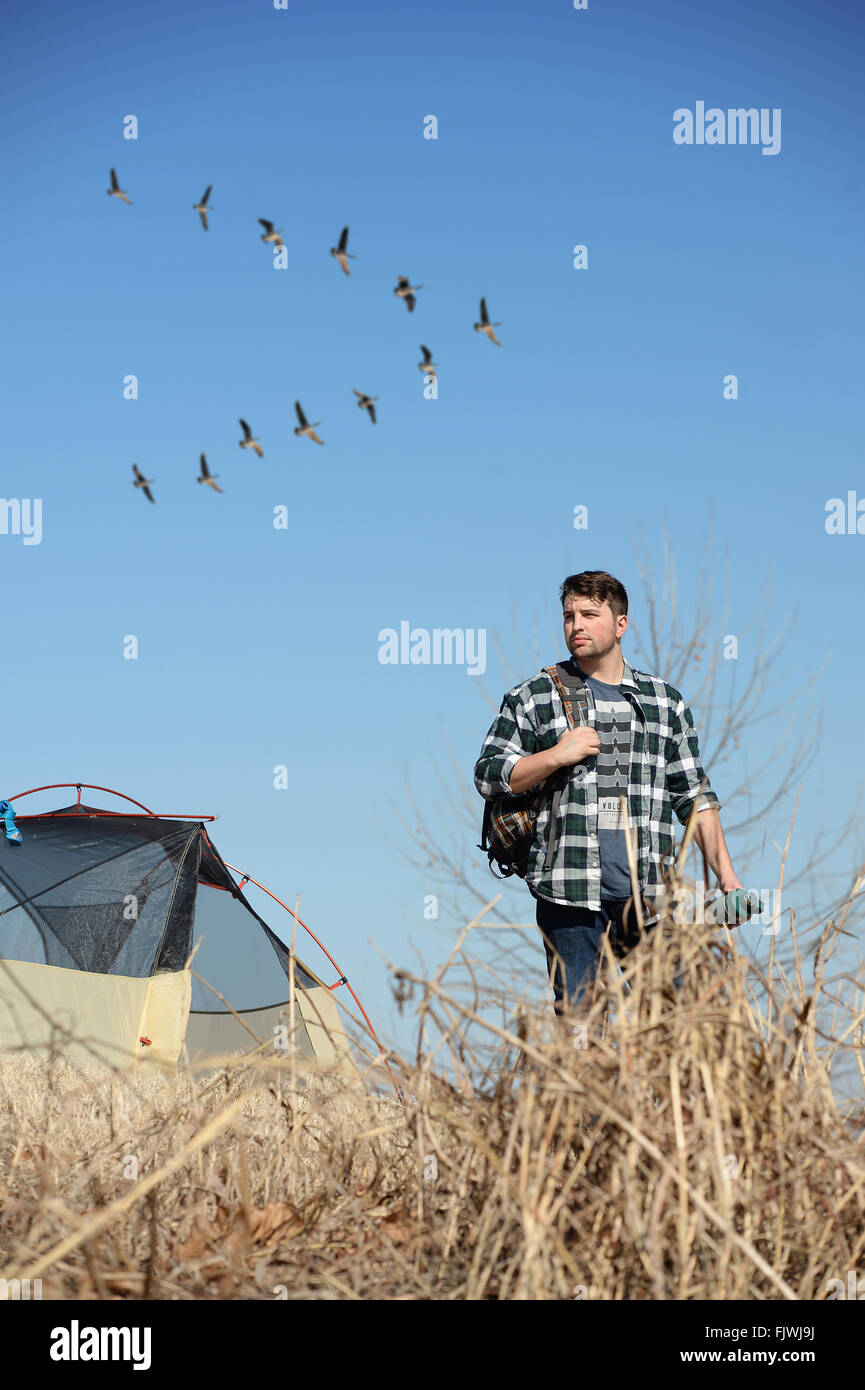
477 663 588 878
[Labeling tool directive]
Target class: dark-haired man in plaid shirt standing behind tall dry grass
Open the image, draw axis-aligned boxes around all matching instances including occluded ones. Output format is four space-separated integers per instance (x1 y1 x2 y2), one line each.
474 570 743 1015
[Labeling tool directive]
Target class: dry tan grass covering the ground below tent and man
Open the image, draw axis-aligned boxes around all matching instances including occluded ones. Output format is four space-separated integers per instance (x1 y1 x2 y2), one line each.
0 900 865 1300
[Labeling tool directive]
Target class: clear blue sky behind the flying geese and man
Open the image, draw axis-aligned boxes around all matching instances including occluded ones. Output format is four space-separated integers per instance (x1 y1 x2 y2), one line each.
0 0 865 1041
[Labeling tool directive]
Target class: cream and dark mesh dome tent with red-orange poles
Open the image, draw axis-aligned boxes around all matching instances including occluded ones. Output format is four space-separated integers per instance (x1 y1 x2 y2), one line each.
0 783 377 1076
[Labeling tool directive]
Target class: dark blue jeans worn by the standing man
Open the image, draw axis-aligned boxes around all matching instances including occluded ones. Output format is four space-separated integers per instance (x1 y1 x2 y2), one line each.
533 894 670 1015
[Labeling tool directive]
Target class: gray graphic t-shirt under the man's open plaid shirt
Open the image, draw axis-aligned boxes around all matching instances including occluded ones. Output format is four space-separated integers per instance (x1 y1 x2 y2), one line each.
577 667 637 898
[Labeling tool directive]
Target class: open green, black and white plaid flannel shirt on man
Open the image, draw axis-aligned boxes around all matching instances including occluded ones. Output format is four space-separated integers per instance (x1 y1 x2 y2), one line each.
474 662 720 910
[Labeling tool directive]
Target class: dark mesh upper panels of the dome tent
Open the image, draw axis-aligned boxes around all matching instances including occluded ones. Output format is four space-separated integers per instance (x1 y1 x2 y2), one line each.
0 803 321 1012
